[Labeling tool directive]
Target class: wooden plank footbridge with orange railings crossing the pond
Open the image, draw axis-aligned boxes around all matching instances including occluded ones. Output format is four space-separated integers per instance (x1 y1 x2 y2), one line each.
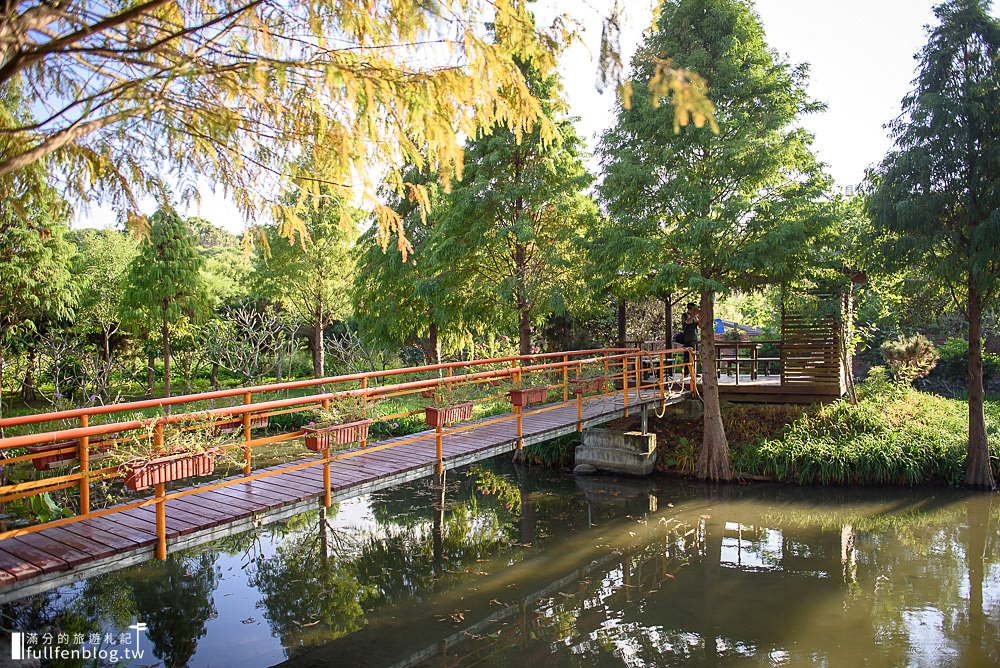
0 349 694 602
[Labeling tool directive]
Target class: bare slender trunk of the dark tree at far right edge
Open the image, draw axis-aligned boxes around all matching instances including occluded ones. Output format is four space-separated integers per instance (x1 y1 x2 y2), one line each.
965 275 996 489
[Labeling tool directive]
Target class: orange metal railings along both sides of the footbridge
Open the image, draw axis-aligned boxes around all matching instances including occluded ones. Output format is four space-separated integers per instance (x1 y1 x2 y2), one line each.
0 348 696 559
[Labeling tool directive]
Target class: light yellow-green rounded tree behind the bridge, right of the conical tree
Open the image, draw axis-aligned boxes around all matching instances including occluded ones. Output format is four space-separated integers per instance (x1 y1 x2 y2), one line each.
255 197 357 378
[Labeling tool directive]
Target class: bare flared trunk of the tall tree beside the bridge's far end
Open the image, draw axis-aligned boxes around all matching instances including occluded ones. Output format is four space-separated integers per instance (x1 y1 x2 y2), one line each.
694 289 733 480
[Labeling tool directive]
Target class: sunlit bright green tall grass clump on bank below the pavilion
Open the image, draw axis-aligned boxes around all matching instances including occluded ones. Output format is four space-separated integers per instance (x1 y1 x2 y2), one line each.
734 369 1000 485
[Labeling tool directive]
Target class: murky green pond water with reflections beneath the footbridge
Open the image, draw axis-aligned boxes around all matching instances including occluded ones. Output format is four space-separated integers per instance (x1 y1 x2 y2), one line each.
3 462 1000 668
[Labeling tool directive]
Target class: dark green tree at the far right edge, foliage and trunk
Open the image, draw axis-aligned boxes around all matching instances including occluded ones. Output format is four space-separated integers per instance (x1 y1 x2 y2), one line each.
868 0 1000 488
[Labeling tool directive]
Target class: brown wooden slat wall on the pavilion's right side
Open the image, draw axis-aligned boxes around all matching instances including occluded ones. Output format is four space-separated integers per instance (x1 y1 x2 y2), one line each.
781 302 844 393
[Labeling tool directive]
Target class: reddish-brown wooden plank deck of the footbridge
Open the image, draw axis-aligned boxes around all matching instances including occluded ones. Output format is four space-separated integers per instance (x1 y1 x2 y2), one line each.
0 390 687 603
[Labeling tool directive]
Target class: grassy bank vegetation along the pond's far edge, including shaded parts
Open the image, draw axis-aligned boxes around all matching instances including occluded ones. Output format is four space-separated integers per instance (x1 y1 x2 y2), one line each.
613 377 1000 486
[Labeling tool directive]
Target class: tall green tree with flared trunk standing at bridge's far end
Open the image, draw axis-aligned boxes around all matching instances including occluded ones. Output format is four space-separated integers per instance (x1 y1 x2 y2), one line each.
600 0 830 480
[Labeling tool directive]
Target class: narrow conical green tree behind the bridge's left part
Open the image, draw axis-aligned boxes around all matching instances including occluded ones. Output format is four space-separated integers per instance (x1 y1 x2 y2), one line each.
122 207 208 397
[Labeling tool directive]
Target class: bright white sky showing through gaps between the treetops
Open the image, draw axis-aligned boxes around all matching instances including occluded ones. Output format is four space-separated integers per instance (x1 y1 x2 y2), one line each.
75 0 952 233
